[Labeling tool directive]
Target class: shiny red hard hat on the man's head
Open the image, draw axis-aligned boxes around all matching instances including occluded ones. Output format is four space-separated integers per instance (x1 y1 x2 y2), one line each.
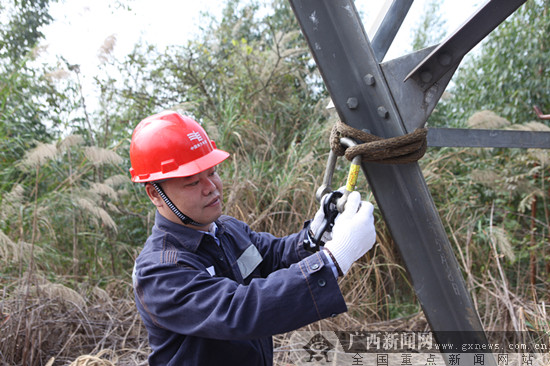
130 111 229 183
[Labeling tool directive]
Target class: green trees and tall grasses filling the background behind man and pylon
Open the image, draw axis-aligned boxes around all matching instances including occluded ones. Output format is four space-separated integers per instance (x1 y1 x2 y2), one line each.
0 0 550 365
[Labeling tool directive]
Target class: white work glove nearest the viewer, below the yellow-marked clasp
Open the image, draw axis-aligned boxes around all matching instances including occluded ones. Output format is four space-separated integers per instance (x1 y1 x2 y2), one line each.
325 191 376 275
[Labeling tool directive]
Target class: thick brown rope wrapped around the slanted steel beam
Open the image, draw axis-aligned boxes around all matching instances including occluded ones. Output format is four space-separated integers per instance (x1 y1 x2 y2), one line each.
330 121 428 164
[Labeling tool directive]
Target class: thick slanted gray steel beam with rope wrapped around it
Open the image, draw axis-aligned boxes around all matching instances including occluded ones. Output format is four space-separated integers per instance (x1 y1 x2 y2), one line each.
290 0 496 365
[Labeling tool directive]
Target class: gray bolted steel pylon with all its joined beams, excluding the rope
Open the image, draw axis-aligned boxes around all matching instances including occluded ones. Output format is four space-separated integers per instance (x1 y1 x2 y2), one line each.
289 0 550 365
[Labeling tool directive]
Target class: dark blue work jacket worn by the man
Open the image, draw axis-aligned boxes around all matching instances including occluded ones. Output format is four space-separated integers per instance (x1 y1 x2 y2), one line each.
133 212 347 366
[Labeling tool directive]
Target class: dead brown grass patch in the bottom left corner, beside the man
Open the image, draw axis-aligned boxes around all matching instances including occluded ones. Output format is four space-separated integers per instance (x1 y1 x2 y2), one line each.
0 276 149 366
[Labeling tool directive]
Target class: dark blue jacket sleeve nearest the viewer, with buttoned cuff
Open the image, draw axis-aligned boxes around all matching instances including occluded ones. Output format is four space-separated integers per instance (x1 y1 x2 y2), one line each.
134 249 347 340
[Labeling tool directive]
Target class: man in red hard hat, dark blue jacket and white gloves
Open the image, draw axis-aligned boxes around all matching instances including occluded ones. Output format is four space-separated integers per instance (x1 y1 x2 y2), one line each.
130 111 376 366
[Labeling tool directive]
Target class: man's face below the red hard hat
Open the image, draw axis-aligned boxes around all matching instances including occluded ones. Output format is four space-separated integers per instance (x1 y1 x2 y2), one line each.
154 167 223 231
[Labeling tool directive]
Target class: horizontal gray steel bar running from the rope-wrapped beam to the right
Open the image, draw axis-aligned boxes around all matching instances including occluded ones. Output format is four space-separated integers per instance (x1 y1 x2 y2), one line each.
427 128 550 149
